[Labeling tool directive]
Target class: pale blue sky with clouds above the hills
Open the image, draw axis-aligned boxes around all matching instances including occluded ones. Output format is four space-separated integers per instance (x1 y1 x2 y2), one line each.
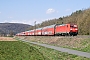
0 0 90 25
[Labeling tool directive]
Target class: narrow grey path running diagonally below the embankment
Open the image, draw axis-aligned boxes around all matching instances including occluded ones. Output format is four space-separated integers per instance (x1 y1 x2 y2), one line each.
22 40 90 58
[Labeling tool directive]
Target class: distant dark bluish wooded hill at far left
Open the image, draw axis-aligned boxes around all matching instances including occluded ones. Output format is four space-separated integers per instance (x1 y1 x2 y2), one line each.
0 23 31 36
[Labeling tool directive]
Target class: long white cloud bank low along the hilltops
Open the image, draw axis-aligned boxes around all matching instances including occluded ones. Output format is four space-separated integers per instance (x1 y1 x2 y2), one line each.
3 17 58 25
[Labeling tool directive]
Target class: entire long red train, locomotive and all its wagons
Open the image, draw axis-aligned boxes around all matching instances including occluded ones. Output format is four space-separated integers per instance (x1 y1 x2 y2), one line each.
16 24 78 36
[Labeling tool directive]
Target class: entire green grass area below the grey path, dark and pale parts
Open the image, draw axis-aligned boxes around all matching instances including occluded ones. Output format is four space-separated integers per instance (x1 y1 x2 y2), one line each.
0 37 90 60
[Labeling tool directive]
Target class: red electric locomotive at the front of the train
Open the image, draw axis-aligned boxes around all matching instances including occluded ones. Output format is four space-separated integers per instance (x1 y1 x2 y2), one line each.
55 24 78 36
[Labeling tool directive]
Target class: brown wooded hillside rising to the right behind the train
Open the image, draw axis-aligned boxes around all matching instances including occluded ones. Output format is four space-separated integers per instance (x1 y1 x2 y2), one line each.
29 8 90 35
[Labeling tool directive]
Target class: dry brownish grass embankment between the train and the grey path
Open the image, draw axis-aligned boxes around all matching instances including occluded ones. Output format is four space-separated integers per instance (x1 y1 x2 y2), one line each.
16 36 90 53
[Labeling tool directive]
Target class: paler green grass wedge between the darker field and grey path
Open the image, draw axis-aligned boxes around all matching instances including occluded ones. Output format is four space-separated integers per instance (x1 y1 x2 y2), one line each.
28 43 90 60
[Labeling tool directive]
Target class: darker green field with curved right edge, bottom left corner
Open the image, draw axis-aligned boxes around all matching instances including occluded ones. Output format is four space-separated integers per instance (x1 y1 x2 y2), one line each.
0 41 45 60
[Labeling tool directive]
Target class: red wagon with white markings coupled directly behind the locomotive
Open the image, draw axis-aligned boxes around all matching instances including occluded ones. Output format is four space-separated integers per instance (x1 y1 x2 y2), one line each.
42 25 55 35
